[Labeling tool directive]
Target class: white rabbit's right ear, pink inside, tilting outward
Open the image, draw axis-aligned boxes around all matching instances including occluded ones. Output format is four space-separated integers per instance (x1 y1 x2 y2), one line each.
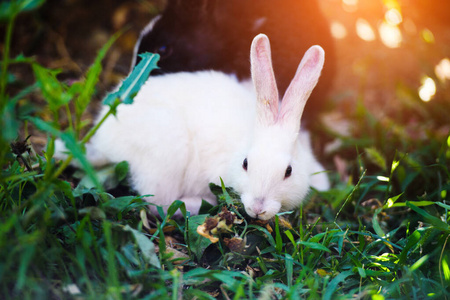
278 46 325 131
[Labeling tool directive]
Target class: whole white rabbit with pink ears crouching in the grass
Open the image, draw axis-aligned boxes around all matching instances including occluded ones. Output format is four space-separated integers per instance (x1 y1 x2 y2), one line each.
74 34 329 220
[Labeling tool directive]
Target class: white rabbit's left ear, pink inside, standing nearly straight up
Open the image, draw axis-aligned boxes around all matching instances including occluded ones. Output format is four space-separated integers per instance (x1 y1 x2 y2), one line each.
250 34 278 125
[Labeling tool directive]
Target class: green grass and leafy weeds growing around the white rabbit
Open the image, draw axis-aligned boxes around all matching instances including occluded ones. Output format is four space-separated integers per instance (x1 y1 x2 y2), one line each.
0 1 450 300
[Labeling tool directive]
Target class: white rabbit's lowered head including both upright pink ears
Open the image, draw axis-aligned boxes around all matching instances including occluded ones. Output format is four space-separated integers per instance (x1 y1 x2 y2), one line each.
237 34 325 220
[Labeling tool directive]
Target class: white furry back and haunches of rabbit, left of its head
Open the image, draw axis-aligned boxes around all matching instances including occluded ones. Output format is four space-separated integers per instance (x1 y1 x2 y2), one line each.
88 71 255 204
